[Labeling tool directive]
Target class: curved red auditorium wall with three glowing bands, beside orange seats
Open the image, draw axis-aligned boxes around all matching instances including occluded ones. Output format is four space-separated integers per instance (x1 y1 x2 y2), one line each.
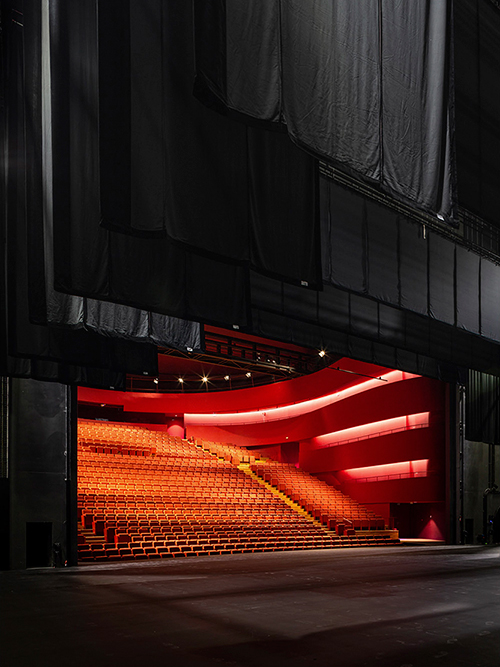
79 359 446 537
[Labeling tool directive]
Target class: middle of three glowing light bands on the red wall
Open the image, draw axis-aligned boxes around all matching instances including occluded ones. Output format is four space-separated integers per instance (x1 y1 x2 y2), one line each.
311 412 429 447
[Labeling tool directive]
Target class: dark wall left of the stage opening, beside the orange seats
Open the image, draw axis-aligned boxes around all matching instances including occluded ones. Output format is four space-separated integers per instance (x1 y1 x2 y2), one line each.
9 379 76 569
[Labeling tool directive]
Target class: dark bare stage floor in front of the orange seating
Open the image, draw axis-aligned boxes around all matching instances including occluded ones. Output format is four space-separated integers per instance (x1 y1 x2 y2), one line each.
0 546 500 667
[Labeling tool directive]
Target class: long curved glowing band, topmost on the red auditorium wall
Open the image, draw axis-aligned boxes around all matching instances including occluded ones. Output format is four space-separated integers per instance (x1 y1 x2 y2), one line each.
184 371 420 426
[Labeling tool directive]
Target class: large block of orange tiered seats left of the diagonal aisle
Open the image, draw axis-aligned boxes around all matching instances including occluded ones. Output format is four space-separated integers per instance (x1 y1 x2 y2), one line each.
78 421 351 560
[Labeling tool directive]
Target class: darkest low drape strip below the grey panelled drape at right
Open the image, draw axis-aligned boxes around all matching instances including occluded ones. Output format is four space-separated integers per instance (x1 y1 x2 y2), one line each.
251 273 500 383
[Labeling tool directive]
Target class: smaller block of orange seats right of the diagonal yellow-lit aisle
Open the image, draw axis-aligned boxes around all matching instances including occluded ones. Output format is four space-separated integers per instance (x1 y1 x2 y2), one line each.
251 461 385 535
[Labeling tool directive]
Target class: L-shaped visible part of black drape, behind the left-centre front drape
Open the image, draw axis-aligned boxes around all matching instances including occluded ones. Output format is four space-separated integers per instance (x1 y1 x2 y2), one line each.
45 0 248 326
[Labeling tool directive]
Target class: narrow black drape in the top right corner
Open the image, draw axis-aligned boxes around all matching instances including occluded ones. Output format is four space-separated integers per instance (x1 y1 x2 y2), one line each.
453 0 500 226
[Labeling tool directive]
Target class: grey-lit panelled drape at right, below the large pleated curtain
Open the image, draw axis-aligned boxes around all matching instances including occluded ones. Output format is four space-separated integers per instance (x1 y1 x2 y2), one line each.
320 178 500 341
